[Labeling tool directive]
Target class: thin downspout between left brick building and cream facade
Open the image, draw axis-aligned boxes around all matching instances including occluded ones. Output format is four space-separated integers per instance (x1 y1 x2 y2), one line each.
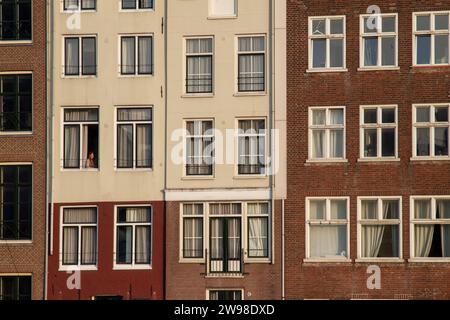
44 0 54 300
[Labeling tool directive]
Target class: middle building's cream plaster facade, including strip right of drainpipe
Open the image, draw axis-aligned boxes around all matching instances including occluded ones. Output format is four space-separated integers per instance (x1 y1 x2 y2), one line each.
166 0 286 201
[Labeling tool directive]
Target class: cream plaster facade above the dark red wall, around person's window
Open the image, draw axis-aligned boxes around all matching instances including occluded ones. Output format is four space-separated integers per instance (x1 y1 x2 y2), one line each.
51 0 165 203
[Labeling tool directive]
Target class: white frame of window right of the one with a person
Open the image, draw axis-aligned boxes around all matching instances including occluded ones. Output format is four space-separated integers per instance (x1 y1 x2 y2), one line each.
113 105 155 171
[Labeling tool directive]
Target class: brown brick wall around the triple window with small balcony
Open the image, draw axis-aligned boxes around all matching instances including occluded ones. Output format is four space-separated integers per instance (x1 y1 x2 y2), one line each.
166 201 281 300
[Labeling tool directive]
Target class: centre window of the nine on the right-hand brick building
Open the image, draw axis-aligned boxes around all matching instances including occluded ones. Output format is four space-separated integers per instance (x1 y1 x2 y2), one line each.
360 106 398 159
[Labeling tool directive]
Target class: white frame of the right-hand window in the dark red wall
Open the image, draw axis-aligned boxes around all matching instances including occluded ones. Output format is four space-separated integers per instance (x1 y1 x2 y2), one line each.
113 204 154 270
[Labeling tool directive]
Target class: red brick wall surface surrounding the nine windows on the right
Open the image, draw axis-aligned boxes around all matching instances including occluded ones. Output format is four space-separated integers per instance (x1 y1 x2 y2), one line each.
286 0 450 299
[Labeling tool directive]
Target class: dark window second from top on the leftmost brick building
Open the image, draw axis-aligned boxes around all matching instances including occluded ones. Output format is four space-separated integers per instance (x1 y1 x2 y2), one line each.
0 74 33 132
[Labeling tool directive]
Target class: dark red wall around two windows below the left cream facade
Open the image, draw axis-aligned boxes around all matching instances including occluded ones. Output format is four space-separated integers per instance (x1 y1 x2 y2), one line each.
48 201 164 300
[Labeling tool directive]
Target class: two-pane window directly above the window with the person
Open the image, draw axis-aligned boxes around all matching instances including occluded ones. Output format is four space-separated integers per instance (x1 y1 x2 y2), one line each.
64 36 97 76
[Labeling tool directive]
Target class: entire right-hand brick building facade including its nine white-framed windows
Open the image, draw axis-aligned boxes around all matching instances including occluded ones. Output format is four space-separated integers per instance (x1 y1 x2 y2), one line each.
285 0 450 299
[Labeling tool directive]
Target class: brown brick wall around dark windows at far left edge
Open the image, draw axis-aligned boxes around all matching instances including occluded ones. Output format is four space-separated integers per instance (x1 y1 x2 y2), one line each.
0 1 46 300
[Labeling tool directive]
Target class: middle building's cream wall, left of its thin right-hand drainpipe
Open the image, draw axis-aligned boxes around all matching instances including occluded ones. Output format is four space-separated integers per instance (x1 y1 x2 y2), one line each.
167 0 270 191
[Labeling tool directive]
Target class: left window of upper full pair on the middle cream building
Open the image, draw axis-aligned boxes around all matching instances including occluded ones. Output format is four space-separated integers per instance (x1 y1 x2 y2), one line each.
186 37 213 94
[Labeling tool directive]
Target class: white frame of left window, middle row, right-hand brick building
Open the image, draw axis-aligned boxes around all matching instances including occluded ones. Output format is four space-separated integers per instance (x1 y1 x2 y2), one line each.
306 106 348 162
